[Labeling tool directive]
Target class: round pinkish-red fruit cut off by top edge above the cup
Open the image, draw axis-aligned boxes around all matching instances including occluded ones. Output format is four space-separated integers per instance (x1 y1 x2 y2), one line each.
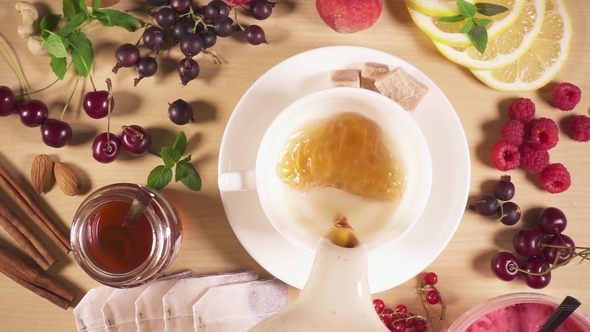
316 0 383 33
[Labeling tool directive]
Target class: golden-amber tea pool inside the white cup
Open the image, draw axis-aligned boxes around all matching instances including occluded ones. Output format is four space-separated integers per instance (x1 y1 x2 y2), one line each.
277 112 405 201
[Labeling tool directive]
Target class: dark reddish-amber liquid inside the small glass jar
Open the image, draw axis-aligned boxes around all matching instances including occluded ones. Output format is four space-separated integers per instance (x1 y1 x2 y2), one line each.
88 201 154 273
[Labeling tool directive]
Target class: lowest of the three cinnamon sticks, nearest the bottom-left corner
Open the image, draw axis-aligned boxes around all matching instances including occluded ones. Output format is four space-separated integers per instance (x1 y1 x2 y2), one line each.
0 241 76 309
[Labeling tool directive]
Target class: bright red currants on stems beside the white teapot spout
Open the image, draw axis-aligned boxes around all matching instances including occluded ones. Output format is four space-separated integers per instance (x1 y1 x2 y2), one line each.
373 272 446 332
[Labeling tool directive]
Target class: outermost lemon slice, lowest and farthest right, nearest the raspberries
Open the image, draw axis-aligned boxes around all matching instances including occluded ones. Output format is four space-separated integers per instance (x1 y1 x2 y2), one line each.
471 0 573 92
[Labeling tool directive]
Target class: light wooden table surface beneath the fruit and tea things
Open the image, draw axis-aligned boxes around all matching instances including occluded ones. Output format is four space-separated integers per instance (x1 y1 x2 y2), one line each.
0 0 590 332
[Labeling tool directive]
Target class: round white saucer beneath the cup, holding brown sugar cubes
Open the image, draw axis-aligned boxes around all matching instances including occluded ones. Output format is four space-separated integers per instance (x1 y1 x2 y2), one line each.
218 46 471 293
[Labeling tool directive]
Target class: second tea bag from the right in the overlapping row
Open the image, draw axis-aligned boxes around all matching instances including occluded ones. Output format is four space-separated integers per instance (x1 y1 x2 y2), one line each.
162 271 258 332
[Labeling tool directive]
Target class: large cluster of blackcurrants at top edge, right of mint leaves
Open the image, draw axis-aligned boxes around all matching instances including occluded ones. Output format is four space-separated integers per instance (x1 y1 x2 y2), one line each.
113 0 276 86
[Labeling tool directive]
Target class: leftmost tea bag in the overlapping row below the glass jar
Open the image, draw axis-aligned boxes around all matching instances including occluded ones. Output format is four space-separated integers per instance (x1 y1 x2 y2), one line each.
74 286 115 332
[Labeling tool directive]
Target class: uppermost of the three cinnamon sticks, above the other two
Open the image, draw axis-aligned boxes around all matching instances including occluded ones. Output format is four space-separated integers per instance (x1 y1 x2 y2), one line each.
0 163 71 254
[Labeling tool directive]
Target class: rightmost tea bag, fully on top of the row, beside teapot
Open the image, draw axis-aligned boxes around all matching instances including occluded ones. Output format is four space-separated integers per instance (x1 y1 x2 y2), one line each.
193 279 289 332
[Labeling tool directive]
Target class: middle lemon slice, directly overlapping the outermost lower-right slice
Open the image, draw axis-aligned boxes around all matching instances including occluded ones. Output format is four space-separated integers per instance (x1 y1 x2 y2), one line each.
434 0 551 70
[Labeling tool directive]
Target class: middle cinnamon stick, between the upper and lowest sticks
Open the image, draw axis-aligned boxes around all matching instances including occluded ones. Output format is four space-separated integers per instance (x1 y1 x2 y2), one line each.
0 202 57 270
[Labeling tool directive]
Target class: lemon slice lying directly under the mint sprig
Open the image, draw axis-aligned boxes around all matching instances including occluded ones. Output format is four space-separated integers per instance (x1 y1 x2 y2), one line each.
408 0 526 47
